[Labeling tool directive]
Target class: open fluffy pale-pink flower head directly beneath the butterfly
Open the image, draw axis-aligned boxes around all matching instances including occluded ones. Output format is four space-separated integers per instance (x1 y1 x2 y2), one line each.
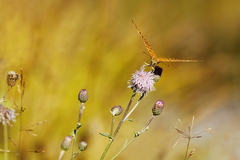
128 66 155 93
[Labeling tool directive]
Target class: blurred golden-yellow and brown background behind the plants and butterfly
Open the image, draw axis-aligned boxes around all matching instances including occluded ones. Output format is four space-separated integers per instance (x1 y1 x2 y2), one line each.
0 0 240 160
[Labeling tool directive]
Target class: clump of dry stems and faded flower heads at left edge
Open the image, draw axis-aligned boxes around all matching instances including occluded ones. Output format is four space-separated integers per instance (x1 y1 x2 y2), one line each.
0 67 47 159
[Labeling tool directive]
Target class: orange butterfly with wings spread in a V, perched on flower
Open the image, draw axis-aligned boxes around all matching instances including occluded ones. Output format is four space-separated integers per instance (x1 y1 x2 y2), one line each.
132 20 202 68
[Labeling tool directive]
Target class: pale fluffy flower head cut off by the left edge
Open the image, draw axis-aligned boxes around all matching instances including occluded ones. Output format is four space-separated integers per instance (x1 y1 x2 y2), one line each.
0 104 17 125
